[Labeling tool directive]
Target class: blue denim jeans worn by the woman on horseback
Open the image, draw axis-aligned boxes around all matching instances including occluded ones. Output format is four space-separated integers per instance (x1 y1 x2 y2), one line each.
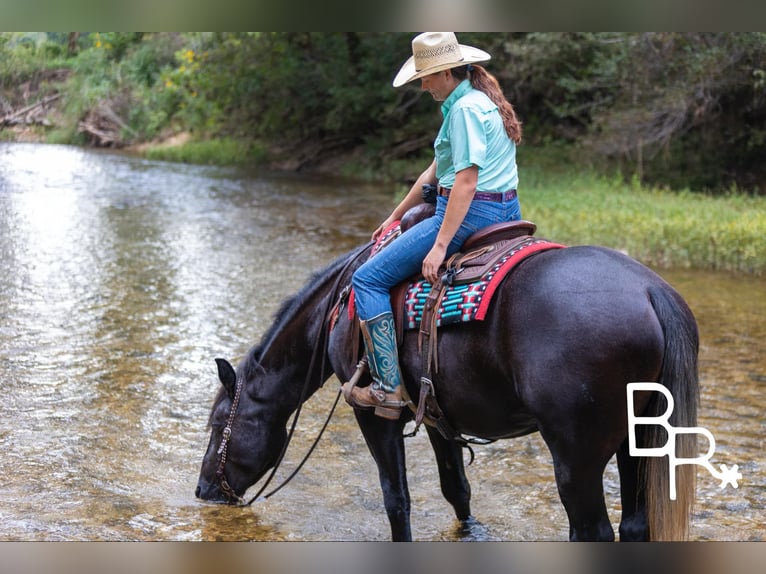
351 197 521 321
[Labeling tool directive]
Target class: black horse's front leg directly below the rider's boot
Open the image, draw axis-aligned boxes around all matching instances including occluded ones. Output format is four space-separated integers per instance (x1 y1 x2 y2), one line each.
354 409 412 542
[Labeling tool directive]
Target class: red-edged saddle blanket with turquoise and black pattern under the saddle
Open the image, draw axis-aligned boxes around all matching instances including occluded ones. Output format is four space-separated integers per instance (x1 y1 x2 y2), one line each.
348 226 564 330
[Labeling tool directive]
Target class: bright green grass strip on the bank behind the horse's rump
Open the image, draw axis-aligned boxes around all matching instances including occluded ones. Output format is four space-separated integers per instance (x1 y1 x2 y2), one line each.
520 147 766 275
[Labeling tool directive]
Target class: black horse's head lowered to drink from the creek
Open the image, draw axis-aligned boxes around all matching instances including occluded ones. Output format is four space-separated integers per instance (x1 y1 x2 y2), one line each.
196 359 287 504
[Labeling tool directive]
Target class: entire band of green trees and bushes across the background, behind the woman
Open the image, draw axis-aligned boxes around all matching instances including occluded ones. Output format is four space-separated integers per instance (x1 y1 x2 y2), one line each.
0 32 766 193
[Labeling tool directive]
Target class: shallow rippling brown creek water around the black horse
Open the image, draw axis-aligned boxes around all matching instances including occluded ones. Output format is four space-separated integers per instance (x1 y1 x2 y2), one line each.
0 144 766 541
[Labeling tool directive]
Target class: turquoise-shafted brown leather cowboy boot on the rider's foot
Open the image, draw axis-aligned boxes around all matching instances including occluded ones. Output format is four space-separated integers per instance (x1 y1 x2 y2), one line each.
343 312 408 420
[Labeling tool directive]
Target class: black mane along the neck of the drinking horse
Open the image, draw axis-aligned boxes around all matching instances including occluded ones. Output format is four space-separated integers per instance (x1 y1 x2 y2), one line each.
207 243 370 418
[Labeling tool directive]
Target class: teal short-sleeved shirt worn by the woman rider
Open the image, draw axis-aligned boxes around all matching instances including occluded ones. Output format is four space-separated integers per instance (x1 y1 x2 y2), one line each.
434 80 519 192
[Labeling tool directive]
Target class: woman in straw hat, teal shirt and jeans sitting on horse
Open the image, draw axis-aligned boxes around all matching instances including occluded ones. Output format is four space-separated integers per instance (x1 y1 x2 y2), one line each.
344 32 521 420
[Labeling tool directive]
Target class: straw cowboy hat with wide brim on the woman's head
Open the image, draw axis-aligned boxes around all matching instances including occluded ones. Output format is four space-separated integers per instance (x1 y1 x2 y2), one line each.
394 32 492 88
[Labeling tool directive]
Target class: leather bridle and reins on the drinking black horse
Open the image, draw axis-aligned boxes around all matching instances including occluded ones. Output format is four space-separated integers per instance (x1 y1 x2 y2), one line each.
210 242 372 506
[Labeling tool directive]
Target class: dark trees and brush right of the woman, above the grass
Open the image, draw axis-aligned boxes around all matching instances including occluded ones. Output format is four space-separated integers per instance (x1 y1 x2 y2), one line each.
507 32 766 191
